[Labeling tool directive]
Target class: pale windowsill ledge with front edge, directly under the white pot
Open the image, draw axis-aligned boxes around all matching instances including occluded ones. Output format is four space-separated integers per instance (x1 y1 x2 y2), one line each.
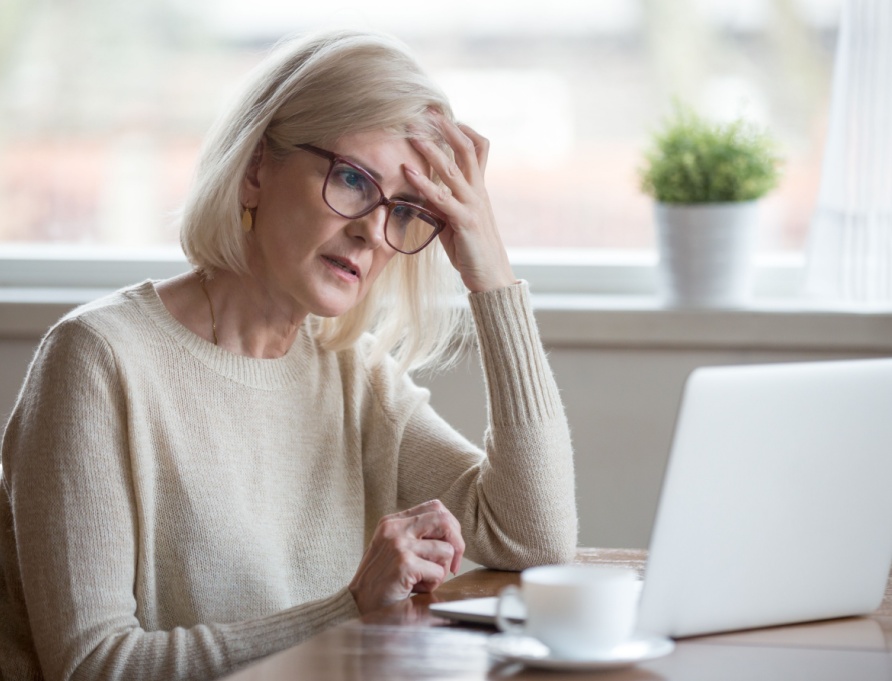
0 287 892 353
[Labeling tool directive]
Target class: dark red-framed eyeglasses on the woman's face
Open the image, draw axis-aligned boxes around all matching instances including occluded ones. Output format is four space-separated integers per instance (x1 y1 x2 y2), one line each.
297 144 446 255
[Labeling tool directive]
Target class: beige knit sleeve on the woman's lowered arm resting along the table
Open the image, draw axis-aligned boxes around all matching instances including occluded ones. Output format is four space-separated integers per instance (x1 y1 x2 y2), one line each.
0 320 358 681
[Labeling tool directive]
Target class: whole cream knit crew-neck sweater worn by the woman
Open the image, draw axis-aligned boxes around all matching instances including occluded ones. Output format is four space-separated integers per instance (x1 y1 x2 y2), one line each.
0 282 576 681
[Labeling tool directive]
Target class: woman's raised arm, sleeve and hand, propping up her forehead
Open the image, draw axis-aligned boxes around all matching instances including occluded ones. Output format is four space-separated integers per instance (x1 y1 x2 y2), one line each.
400 113 577 569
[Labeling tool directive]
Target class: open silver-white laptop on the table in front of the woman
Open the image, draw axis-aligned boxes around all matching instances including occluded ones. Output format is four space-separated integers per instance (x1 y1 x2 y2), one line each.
431 359 892 638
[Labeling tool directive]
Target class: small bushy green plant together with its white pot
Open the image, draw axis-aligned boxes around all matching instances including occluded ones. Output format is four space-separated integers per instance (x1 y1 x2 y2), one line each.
641 105 780 307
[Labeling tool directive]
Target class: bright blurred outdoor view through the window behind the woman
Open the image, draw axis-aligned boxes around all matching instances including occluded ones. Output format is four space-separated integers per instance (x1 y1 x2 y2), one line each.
0 0 840 253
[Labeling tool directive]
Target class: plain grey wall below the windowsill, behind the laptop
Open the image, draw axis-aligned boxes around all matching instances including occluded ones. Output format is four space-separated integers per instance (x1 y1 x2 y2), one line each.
422 347 869 548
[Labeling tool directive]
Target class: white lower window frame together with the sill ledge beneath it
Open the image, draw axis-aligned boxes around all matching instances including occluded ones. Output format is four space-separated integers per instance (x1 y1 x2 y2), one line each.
0 245 892 354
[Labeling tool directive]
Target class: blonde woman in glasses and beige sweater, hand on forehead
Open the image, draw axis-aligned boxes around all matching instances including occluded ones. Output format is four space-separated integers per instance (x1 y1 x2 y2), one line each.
0 32 576 681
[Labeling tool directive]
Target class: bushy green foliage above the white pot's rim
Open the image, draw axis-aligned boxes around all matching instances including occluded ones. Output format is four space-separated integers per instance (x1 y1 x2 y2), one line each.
640 104 781 203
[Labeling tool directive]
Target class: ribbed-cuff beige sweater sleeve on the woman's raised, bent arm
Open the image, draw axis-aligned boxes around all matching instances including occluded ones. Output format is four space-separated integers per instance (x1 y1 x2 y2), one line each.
399 282 577 570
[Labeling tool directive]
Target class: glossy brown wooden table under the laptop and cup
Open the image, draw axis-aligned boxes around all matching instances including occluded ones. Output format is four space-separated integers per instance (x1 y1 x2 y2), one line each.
221 549 892 681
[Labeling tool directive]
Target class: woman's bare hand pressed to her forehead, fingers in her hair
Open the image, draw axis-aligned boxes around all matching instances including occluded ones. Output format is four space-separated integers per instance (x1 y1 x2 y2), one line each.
405 113 517 292
